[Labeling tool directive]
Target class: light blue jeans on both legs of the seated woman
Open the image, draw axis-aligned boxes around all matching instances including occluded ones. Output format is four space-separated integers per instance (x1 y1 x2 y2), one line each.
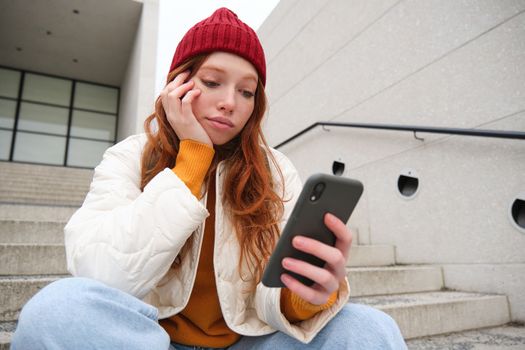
11 278 406 350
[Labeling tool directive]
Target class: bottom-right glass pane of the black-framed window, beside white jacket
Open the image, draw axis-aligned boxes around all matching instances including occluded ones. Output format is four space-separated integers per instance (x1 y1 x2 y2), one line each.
67 138 113 168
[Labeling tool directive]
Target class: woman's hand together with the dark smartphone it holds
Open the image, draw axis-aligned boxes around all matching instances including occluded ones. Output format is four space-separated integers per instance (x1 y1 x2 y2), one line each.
262 174 363 305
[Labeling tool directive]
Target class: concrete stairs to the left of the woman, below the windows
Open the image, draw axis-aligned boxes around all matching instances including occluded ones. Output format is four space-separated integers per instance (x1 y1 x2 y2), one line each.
0 162 93 350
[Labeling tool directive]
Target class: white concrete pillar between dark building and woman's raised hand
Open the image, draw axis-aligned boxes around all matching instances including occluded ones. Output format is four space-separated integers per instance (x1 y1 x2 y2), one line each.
117 0 159 141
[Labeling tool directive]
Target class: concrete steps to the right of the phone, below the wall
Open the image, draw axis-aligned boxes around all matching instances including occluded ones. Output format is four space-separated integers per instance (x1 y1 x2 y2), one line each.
348 241 512 344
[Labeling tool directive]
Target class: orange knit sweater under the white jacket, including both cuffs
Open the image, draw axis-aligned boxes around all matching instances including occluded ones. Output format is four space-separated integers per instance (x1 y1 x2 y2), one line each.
160 140 337 347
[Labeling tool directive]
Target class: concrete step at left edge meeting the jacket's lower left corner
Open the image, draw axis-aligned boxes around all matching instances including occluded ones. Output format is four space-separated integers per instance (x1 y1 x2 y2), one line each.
0 244 67 276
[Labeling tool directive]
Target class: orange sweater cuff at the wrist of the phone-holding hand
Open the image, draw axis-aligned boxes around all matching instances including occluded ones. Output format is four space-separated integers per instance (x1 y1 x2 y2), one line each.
281 288 337 323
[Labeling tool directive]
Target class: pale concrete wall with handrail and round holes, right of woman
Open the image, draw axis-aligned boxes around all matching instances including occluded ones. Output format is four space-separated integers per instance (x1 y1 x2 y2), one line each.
259 0 525 321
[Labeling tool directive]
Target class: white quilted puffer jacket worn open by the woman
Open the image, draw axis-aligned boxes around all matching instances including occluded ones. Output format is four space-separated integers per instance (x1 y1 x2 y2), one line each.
64 134 349 342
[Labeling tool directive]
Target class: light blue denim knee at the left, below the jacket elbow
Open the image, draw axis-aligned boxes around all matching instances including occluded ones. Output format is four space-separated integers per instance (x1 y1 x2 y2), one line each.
11 278 169 350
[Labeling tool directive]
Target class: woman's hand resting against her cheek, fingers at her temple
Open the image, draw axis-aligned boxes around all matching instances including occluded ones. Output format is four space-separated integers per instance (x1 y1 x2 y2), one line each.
160 71 213 147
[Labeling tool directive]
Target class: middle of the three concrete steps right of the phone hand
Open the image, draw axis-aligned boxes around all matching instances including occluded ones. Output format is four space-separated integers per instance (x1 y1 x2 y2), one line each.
348 266 443 297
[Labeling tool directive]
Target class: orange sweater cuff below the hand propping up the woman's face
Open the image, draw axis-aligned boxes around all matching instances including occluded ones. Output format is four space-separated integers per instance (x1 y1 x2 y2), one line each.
172 140 215 199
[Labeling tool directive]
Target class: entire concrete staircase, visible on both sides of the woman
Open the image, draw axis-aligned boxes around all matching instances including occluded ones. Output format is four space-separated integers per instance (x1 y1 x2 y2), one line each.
0 162 525 350
